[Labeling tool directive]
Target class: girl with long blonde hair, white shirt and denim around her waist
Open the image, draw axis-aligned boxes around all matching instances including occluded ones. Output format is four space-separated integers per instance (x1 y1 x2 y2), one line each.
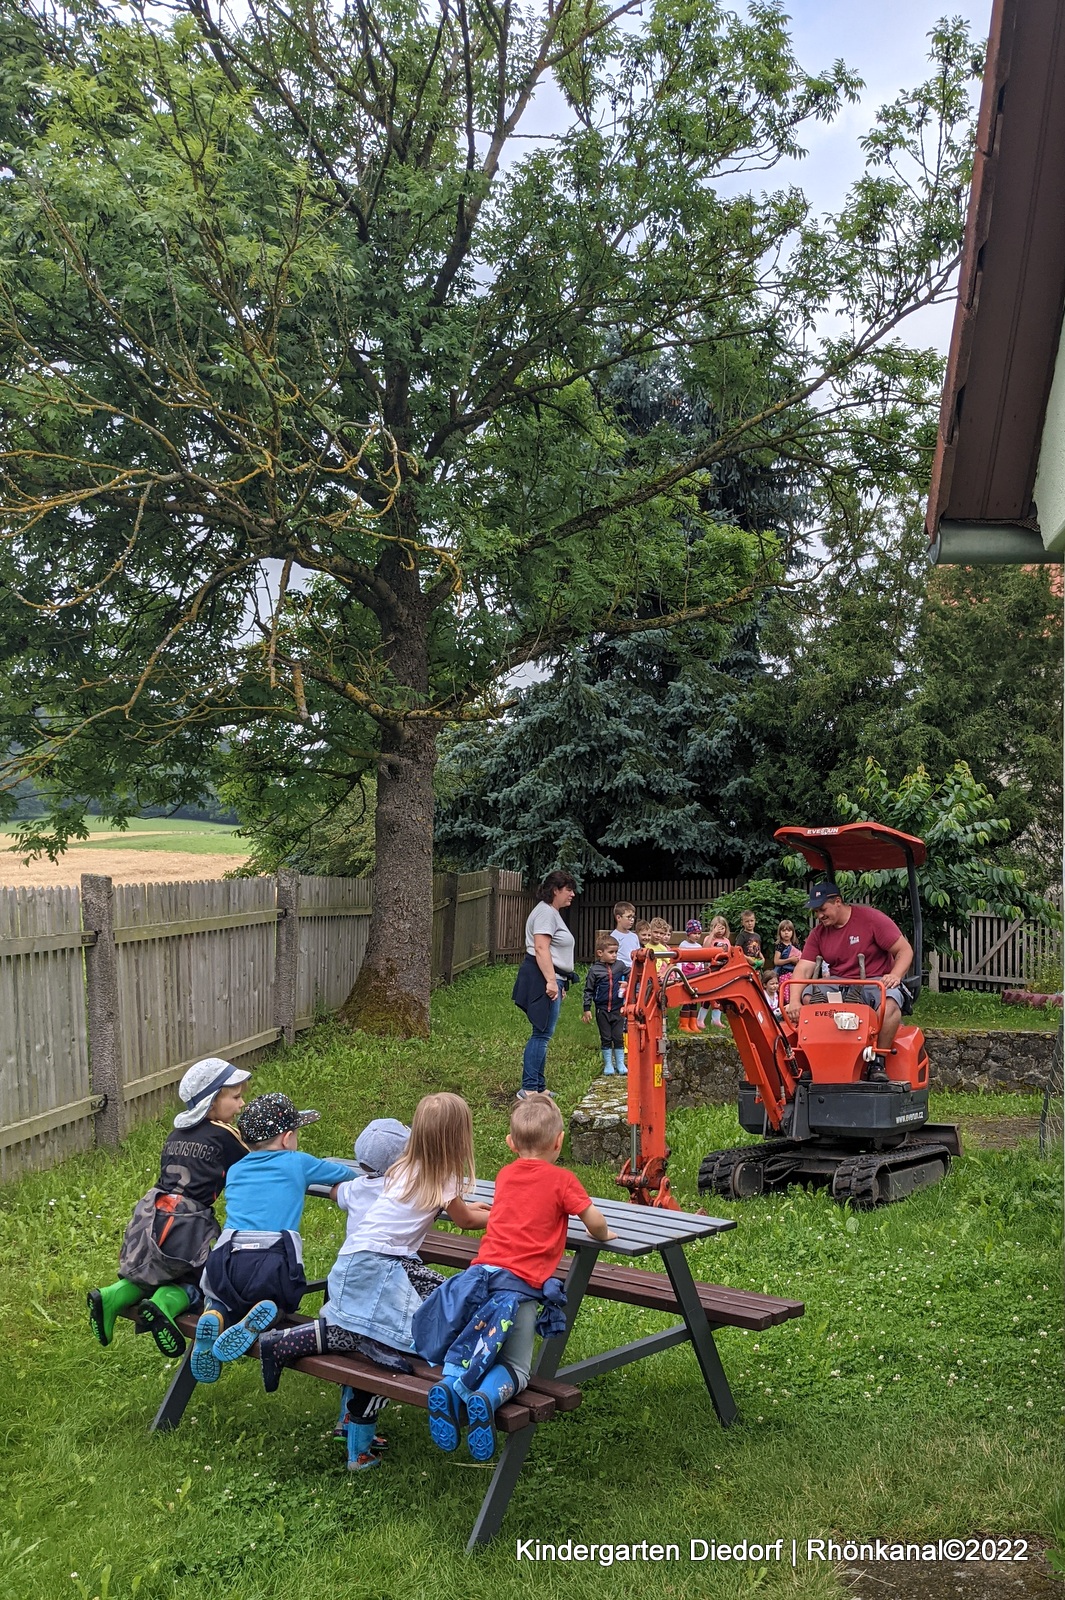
259 1094 488 1472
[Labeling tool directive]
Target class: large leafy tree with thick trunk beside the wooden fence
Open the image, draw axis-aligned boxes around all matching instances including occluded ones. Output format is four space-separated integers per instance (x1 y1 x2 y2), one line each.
0 0 972 1032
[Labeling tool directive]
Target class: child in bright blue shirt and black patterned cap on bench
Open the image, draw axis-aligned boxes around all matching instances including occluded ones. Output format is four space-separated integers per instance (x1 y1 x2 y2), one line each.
189 1093 352 1384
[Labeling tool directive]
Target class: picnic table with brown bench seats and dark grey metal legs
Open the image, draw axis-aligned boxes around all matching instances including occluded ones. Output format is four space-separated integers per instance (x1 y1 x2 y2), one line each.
145 1182 804 1549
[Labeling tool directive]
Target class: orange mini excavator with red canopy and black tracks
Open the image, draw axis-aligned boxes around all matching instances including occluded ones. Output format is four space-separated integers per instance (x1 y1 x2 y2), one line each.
617 822 961 1208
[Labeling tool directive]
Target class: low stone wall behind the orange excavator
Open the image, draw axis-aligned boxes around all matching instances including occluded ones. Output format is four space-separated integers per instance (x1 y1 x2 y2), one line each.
569 1029 1057 1165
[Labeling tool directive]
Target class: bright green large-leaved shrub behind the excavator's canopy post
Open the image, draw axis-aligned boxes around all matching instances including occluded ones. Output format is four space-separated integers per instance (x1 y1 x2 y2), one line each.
784 757 1062 954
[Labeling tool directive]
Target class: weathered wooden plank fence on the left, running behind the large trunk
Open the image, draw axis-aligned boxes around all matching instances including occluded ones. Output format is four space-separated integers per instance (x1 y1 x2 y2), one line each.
0 870 502 1179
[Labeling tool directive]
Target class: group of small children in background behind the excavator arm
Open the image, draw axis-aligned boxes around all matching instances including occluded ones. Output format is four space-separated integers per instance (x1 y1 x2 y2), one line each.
580 901 801 1077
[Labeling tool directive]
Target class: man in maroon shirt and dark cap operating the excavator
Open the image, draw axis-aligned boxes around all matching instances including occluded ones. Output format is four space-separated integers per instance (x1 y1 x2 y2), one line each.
784 883 913 1053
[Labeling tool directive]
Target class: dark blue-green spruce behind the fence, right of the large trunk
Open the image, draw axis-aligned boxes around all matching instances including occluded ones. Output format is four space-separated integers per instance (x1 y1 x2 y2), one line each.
437 629 777 883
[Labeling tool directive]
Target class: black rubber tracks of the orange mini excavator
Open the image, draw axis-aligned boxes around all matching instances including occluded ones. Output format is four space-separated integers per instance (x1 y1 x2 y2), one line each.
699 1138 956 1211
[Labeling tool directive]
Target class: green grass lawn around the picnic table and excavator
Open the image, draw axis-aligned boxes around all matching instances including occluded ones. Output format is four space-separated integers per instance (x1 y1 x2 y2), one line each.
0 970 1062 1600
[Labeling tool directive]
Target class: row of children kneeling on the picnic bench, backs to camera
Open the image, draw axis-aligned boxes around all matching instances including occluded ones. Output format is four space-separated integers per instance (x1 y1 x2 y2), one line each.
88 1059 614 1472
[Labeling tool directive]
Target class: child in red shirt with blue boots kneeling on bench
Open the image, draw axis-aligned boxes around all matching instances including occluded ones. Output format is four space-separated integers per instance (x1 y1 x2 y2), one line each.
424 1094 617 1461
